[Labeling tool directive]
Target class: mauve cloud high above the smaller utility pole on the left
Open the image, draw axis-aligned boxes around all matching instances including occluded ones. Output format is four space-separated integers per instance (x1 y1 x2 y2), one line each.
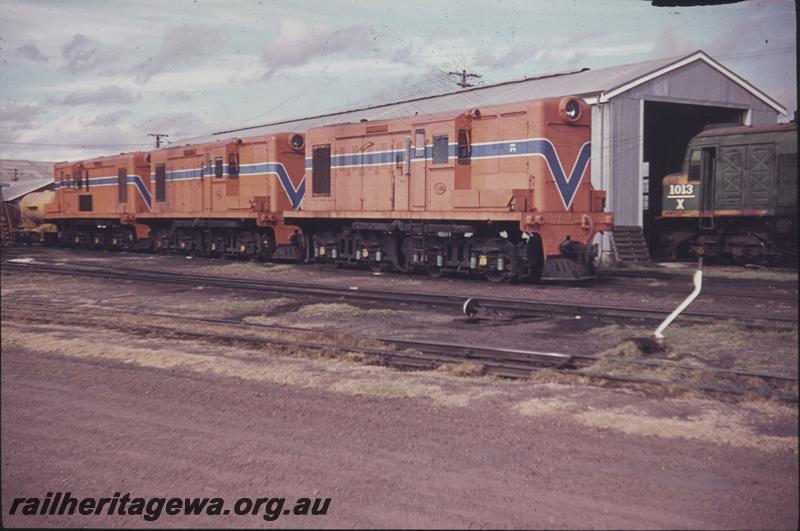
135 24 220 82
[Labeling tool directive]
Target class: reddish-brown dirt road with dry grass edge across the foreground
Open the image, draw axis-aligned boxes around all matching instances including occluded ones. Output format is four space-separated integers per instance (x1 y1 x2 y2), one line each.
2 320 798 528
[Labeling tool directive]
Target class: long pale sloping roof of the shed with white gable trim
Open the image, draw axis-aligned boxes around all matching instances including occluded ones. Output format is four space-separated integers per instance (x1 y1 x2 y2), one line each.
175 50 786 145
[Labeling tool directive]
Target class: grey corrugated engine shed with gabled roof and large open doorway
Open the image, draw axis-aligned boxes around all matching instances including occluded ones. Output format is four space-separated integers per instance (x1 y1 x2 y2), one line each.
178 50 786 263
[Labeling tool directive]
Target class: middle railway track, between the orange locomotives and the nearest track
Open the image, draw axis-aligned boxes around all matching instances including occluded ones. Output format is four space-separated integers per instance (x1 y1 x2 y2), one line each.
2 260 797 326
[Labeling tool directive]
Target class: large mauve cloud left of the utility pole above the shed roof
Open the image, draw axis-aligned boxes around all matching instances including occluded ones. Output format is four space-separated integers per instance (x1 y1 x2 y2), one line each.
261 17 376 78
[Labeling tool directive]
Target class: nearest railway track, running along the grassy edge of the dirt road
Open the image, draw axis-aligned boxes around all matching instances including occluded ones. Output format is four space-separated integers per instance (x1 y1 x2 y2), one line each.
3 301 798 402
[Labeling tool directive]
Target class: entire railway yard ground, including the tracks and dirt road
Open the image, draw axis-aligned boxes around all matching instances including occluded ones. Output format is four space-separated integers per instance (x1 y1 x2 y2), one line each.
2 247 798 529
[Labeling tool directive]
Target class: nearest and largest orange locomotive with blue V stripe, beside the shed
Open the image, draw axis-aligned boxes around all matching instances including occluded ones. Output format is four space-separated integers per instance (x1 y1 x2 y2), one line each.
285 97 612 281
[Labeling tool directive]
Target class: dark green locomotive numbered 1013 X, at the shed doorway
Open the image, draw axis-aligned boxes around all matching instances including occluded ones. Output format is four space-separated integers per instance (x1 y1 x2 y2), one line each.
660 123 798 262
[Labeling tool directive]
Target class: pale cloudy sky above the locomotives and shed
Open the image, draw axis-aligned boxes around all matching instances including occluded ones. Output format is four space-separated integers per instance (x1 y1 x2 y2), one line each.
0 0 797 161
